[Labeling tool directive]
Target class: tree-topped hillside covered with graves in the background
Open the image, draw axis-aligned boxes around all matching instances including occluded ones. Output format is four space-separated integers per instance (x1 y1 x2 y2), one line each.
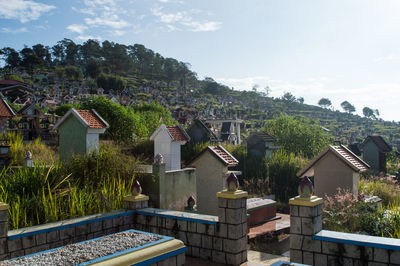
0 39 400 150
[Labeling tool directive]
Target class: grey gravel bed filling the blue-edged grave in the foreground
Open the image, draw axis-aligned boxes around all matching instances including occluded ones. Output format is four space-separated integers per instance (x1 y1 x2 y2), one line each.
0 231 162 266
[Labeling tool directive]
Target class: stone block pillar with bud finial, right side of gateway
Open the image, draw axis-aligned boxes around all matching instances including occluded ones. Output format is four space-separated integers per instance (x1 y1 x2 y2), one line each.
289 177 326 265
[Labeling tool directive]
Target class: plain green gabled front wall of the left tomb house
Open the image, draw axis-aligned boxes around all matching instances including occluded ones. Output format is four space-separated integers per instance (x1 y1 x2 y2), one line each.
58 115 87 160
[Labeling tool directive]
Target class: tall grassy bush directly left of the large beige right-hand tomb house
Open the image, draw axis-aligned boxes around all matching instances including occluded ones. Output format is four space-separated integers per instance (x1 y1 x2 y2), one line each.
267 150 306 202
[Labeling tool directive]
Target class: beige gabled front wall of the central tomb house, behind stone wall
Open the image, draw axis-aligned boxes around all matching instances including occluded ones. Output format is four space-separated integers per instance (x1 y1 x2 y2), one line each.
192 152 228 215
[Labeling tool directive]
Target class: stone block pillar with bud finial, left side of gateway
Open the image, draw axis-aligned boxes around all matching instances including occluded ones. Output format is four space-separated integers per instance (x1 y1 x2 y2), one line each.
216 174 248 265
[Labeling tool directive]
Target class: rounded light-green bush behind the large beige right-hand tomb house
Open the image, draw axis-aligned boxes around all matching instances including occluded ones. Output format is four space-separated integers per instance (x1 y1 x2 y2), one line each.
263 115 331 158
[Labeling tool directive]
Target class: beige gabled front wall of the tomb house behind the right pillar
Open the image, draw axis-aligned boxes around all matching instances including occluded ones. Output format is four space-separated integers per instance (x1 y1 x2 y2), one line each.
314 153 358 197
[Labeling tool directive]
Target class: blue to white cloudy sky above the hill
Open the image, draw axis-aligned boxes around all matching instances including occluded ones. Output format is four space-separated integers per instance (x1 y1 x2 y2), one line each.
0 0 400 121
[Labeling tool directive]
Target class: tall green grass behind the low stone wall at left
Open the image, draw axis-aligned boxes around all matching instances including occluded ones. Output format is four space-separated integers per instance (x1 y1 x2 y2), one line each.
0 135 138 230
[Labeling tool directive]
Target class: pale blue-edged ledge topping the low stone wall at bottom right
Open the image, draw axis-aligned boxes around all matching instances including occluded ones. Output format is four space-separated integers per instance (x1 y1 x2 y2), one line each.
312 230 400 250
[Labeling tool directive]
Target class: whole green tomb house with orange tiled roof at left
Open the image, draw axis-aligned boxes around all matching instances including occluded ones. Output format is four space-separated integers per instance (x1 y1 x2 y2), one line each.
54 108 109 160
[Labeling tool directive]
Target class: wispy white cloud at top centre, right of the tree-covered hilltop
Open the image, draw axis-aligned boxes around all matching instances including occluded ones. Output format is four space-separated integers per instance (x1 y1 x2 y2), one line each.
150 7 222 32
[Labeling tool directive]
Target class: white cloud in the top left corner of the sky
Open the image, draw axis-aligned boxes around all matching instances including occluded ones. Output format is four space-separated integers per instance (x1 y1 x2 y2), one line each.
0 0 56 23
